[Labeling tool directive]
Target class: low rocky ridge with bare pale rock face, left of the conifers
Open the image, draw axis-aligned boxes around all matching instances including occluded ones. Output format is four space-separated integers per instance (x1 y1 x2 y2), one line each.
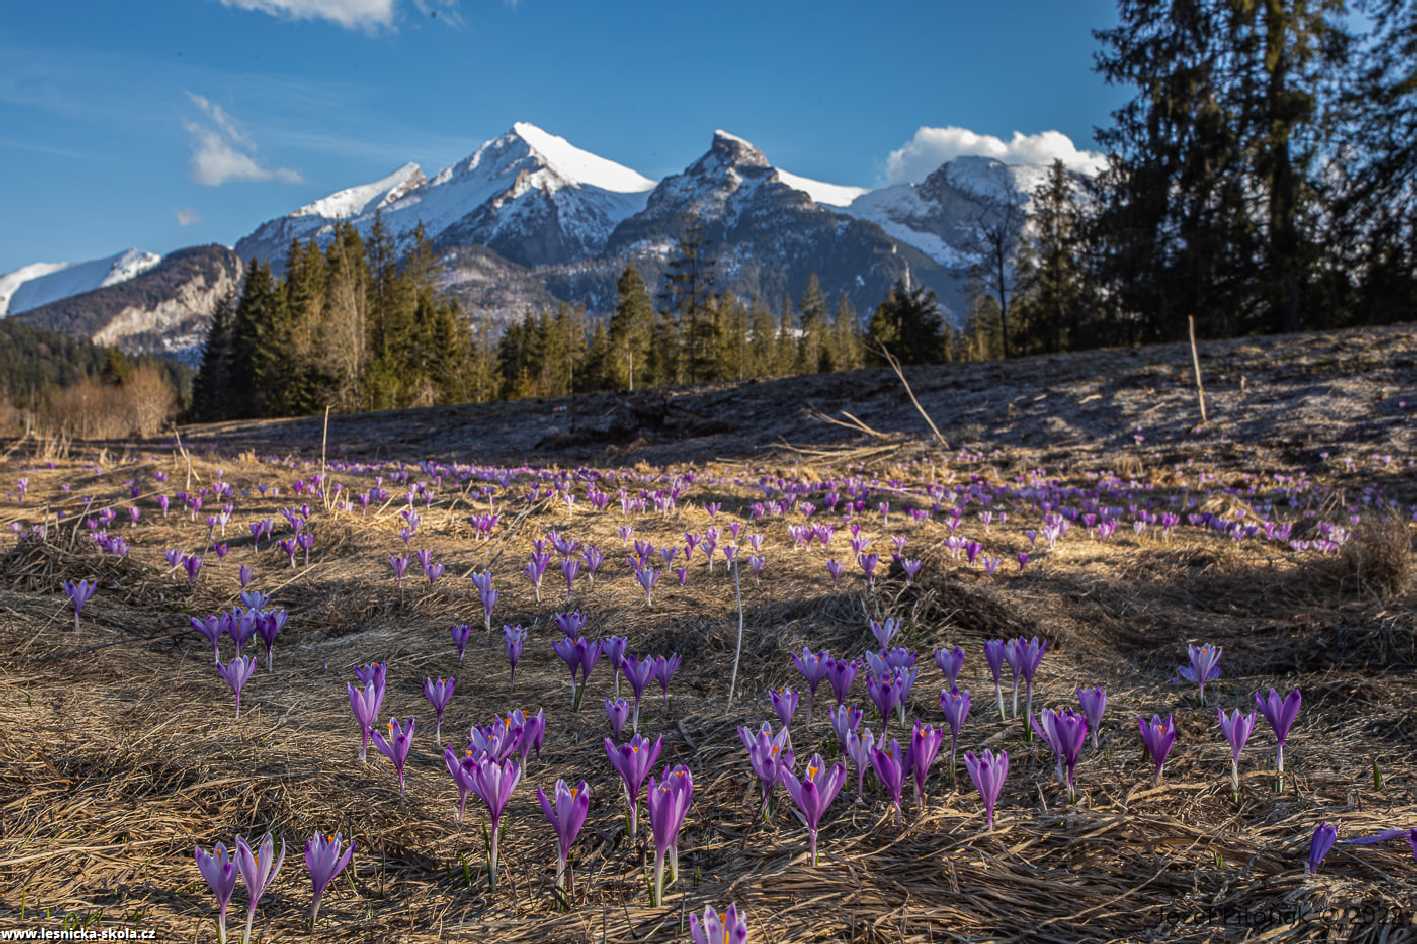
13 245 241 360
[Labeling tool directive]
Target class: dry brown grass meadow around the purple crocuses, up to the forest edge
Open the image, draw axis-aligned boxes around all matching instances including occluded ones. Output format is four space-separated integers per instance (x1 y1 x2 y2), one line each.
0 321 1417 944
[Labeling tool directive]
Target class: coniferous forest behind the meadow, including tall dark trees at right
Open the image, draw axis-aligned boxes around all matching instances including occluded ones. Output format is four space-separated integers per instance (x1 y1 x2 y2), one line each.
191 0 1417 420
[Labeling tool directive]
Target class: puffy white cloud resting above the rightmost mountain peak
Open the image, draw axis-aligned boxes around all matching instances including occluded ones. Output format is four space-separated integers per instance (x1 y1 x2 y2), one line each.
886 128 1105 183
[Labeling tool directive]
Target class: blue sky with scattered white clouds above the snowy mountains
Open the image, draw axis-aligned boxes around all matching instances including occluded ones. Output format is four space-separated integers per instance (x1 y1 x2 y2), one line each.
0 0 1124 272
